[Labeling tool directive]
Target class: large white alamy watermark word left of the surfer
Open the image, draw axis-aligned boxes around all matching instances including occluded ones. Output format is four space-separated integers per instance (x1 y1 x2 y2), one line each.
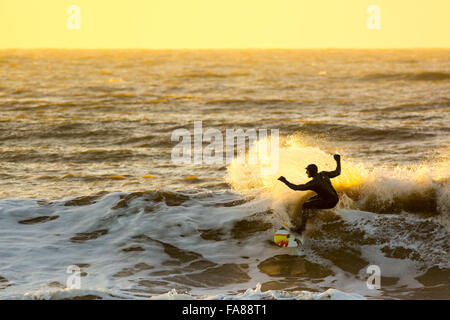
171 121 279 175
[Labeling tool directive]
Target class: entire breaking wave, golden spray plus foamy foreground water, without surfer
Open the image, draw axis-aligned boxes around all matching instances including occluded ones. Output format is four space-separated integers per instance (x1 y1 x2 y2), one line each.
0 136 450 299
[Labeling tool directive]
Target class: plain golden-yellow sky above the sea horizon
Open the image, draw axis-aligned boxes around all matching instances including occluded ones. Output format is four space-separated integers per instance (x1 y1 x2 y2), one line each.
0 0 450 48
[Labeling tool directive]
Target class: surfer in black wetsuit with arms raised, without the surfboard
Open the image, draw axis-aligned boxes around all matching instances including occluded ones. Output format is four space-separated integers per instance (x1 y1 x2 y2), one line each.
278 154 341 234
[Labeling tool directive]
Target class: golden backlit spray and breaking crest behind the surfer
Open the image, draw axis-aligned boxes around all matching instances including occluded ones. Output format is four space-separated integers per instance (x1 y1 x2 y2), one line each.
226 135 450 222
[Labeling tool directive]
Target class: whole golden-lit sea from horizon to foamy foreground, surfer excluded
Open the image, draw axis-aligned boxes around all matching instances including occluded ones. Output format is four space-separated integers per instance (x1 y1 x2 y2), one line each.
0 50 450 299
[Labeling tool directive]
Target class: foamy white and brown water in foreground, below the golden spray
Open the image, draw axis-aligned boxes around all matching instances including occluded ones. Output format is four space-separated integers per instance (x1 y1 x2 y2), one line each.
0 186 449 299
